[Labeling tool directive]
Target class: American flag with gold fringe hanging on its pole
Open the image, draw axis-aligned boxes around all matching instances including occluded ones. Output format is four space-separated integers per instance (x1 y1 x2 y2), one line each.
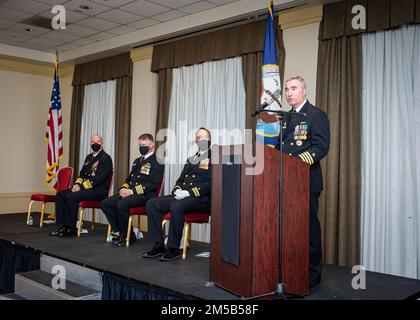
45 61 63 190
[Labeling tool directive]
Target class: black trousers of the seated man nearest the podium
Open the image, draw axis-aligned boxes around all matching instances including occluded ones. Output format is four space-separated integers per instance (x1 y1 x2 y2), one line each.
146 196 210 248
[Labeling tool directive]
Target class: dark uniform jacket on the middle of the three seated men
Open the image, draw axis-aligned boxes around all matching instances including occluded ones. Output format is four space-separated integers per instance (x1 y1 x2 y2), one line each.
121 153 164 198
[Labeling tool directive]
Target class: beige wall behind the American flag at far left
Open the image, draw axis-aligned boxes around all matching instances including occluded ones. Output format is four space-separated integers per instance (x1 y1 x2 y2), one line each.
0 64 72 213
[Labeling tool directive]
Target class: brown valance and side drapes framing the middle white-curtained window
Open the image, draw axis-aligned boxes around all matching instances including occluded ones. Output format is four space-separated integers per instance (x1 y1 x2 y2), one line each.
151 20 285 147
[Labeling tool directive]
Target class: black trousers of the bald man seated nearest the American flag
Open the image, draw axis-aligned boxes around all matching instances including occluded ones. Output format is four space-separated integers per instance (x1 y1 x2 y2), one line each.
55 189 107 228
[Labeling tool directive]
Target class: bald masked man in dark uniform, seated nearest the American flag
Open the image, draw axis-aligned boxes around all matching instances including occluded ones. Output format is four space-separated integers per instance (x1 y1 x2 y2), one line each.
50 135 112 237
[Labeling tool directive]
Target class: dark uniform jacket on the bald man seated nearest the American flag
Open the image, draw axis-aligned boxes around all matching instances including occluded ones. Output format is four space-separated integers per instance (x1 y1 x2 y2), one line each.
75 150 112 192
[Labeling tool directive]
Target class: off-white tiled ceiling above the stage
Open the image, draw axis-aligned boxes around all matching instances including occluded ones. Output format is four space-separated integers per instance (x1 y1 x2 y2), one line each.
0 0 320 64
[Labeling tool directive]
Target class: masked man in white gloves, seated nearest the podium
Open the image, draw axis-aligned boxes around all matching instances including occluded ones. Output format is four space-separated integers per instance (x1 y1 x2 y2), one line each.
143 128 211 261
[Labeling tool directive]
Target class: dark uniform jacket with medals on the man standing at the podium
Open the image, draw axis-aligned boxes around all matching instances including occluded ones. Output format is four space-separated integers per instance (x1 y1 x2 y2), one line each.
283 101 330 193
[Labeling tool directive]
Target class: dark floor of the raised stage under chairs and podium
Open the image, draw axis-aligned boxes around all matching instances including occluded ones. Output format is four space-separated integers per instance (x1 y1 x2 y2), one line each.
0 213 420 300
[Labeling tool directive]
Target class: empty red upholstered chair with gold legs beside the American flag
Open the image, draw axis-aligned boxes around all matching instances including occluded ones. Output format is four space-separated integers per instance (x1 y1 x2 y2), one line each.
26 167 73 228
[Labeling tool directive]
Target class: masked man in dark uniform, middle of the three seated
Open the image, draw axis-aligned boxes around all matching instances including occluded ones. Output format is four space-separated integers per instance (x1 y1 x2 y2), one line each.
101 133 164 247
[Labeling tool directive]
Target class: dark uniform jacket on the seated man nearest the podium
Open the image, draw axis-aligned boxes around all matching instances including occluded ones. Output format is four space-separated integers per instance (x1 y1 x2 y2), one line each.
172 150 212 203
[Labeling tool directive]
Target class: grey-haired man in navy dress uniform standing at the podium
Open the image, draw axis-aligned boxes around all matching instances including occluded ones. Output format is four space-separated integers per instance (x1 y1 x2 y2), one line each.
282 76 330 288
